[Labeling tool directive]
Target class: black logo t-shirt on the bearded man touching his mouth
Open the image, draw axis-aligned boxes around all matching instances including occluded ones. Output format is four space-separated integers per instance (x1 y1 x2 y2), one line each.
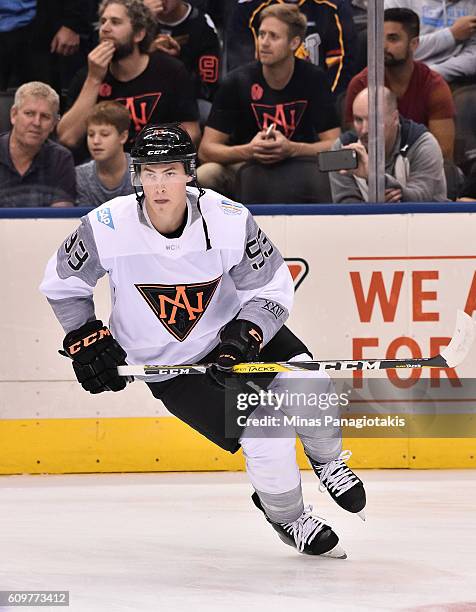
68 51 198 151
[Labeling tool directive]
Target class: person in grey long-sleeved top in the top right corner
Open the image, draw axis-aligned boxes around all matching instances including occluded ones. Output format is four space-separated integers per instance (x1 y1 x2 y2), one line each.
385 0 476 82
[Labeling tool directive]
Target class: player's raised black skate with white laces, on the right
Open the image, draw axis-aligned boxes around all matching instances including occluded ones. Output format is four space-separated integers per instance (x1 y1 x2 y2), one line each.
307 451 366 521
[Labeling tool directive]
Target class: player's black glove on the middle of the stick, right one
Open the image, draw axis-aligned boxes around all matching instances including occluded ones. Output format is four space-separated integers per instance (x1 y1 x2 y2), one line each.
207 319 263 387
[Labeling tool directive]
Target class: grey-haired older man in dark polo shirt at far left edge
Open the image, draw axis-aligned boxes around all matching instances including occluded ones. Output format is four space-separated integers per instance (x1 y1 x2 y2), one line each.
0 81 76 207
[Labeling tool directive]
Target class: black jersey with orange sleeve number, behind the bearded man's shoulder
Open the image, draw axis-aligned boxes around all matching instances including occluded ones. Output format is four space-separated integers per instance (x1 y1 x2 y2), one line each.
157 7 220 100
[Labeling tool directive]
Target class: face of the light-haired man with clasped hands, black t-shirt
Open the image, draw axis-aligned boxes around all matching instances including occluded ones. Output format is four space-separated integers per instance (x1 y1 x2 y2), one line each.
258 17 299 66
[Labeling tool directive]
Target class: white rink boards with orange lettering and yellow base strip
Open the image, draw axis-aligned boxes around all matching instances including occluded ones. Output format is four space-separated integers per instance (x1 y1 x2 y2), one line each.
0 207 476 474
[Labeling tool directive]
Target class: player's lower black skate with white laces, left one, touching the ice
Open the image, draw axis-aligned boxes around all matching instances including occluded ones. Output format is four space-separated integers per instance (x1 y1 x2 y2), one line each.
251 492 347 559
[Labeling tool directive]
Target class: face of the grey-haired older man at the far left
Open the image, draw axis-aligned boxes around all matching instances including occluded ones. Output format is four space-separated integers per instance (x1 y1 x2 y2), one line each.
10 96 57 147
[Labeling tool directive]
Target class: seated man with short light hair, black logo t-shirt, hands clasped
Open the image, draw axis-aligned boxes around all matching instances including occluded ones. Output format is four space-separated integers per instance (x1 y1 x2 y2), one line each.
198 4 340 201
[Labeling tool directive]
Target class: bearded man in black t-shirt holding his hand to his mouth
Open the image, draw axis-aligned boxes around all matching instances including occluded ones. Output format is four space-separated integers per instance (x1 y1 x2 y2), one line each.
58 0 200 151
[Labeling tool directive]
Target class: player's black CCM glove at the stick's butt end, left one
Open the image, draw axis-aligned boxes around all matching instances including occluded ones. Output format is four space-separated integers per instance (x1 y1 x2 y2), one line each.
63 320 127 393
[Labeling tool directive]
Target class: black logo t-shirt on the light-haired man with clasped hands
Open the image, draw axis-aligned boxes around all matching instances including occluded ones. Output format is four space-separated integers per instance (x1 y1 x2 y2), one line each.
207 59 339 145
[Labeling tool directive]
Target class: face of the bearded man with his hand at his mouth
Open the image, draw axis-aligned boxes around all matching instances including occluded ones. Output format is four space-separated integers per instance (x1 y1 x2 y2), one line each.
99 4 144 60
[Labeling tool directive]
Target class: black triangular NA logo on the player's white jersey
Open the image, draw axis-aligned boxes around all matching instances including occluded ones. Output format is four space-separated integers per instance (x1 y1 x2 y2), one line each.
135 276 221 342
